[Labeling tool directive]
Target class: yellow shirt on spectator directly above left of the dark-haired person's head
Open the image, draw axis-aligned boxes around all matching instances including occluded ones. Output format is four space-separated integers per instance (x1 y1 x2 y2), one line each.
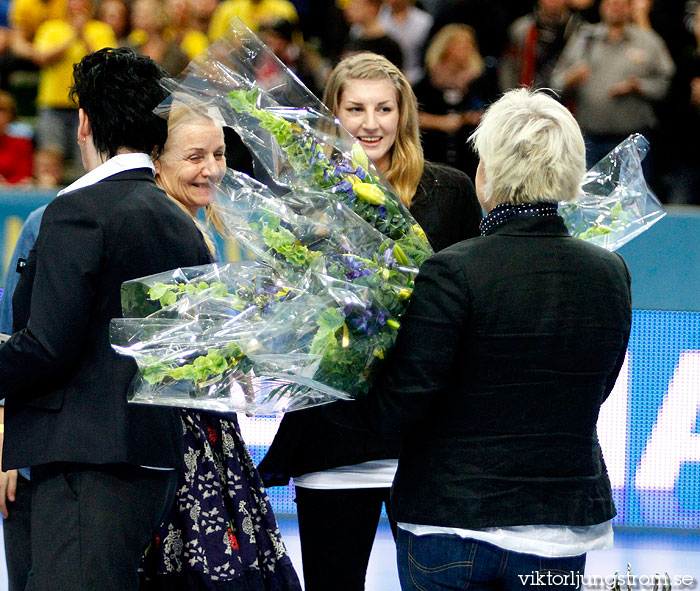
34 19 117 109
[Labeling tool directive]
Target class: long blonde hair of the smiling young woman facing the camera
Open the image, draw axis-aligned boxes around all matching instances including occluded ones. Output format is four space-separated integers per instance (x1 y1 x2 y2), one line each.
323 52 424 206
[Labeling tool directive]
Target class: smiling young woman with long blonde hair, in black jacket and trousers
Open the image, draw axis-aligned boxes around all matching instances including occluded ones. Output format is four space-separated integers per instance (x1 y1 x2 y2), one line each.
258 53 481 591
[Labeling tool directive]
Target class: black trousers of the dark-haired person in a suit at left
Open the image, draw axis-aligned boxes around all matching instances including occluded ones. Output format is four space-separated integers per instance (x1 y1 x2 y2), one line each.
26 463 177 591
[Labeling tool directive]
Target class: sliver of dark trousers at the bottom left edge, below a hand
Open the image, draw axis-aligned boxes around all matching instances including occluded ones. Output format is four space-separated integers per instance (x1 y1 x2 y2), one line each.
2 476 32 591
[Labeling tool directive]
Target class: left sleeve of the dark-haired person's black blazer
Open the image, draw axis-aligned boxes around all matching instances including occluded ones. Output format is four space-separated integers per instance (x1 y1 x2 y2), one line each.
0 198 102 396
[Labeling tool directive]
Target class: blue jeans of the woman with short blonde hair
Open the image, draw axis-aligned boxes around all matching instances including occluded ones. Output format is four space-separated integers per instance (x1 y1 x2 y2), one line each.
396 528 586 591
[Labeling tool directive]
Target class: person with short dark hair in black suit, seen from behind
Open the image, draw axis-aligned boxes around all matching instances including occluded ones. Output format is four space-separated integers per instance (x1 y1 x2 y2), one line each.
0 49 211 591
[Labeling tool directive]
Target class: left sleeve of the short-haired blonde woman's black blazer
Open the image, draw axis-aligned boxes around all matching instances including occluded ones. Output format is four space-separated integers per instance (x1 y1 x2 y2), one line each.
325 254 470 437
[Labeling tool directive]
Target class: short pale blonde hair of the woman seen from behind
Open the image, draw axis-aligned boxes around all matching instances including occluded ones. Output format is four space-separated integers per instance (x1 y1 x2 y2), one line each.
469 88 586 205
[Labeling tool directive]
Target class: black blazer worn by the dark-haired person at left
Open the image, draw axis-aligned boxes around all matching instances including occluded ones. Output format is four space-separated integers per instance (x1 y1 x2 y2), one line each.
0 169 210 469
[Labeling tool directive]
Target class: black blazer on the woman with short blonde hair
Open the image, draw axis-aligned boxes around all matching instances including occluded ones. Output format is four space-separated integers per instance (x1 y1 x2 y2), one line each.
326 216 631 529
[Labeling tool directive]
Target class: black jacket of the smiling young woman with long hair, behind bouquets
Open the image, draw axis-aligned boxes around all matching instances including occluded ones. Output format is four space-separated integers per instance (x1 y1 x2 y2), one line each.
258 163 481 486
